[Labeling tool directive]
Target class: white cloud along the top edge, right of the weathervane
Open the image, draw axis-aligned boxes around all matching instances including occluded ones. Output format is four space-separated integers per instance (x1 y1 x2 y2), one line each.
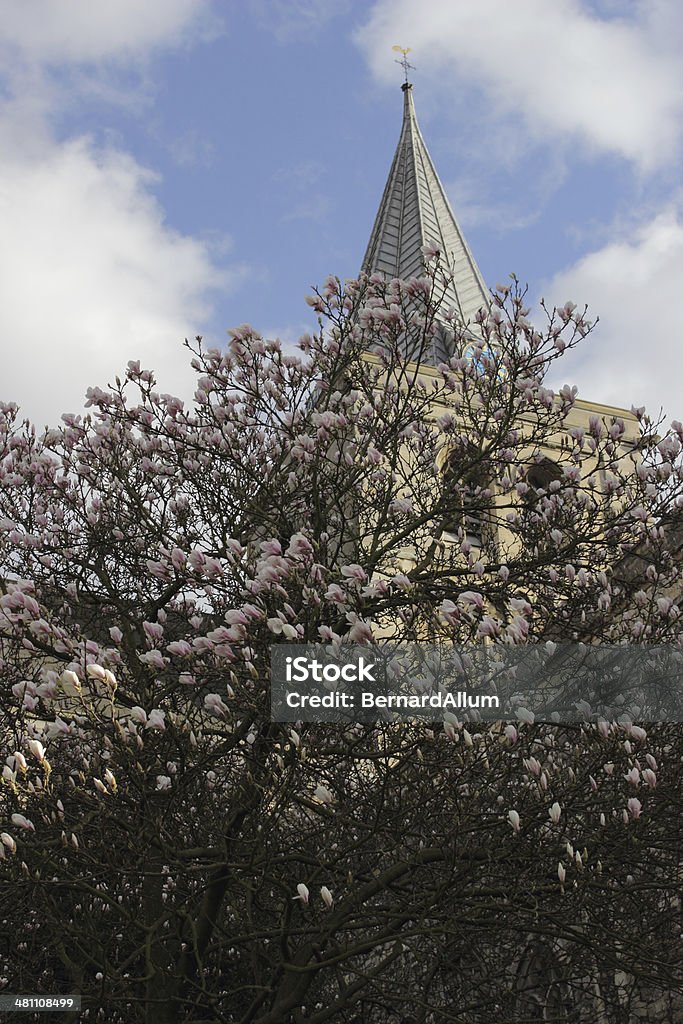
356 0 683 171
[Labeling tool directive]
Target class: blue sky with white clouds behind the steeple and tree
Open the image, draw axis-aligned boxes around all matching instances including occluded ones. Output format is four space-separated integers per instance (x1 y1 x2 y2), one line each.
0 0 683 425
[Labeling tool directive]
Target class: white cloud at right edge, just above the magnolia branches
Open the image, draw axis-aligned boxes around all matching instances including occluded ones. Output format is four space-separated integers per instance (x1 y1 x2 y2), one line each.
546 208 683 419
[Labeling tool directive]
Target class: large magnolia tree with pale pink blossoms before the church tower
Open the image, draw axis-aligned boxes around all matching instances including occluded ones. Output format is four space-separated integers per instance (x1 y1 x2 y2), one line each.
0 264 683 1024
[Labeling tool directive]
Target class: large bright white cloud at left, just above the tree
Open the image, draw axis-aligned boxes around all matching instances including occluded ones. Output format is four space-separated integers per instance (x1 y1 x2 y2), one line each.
0 131 234 425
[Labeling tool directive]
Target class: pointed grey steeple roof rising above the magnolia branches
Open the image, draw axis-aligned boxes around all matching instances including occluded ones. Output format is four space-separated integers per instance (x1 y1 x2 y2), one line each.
361 82 490 323
